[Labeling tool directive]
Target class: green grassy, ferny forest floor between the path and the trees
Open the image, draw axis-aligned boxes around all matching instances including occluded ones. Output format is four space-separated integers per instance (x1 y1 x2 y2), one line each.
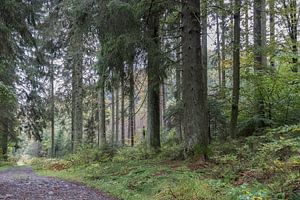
31 126 300 200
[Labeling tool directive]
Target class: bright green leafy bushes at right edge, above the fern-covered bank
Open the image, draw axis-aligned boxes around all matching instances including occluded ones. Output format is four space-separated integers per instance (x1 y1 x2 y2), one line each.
239 60 300 125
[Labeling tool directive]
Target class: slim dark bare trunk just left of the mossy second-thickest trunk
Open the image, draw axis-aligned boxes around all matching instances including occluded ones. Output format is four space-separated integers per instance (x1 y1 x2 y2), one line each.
128 58 135 146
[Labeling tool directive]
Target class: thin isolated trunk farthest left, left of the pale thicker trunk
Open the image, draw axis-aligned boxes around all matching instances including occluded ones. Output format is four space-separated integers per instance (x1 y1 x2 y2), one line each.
50 63 55 157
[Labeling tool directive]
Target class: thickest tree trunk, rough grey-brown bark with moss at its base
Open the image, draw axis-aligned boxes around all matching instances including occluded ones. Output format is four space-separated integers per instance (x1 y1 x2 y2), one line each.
182 0 209 159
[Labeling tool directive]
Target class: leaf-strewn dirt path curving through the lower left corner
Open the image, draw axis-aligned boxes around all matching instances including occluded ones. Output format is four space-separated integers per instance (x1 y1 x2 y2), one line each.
0 167 116 200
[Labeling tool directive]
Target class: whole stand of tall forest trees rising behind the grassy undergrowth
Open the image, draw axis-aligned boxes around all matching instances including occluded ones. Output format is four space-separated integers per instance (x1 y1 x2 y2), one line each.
0 0 300 159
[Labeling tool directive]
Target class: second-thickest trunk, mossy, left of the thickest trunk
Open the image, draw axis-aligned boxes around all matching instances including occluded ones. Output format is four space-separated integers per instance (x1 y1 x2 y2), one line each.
147 14 160 151
